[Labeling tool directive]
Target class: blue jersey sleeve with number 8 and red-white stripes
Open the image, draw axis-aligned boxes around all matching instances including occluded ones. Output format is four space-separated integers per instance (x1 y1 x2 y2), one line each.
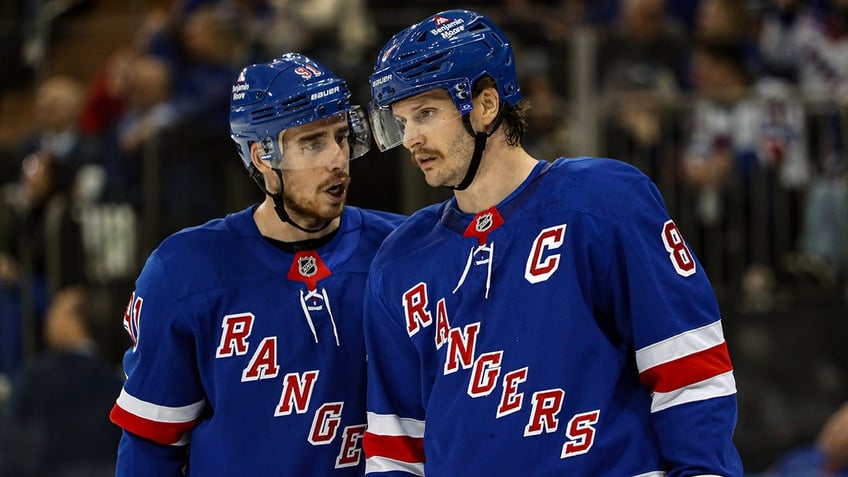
600 170 742 476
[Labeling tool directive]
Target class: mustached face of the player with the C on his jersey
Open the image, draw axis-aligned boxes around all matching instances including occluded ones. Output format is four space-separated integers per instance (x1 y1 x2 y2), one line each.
392 89 474 187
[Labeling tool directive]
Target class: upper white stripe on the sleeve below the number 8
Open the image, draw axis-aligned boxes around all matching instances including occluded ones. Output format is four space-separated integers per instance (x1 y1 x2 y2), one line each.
636 321 724 371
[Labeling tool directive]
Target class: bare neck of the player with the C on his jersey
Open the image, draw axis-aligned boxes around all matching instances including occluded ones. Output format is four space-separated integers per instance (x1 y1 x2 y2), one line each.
454 135 538 214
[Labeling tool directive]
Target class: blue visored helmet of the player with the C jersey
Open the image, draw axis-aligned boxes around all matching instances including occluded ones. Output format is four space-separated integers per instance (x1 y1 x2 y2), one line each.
369 10 521 151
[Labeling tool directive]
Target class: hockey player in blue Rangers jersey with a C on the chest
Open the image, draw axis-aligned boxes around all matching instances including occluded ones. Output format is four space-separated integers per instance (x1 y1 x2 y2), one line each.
364 10 742 477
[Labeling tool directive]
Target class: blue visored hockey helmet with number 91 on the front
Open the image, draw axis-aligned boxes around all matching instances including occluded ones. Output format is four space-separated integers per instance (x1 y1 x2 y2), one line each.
230 53 371 170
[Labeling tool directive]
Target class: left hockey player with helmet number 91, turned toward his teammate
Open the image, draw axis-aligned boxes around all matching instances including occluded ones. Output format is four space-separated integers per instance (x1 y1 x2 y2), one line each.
111 53 402 477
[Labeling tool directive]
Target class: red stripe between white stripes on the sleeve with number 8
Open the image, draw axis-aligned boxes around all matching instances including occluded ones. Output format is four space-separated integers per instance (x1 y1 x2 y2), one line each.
639 343 733 393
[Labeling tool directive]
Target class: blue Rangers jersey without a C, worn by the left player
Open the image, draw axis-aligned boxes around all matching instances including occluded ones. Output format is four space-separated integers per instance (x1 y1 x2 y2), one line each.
111 206 403 477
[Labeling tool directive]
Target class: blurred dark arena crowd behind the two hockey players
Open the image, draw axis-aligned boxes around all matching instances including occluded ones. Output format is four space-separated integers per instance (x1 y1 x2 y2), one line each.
0 0 848 476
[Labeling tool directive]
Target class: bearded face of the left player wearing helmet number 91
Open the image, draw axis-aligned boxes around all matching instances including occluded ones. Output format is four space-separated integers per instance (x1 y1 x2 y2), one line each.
279 113 350 223
